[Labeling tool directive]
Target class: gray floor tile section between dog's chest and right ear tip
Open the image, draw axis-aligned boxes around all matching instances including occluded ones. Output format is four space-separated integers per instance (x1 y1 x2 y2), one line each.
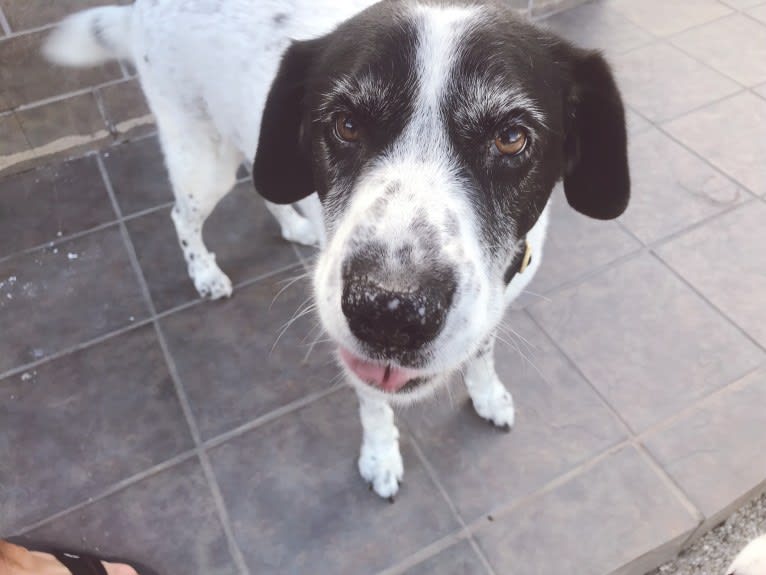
529 194 641 293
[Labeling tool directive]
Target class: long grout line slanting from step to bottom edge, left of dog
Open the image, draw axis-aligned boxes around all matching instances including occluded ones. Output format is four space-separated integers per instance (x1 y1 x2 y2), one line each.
97 154 250 575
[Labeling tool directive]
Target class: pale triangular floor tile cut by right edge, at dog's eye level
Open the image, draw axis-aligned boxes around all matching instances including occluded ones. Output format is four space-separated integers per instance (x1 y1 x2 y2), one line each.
665 93 766 195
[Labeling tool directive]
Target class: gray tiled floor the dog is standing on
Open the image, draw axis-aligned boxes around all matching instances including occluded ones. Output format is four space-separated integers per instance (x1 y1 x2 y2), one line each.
0 0 766 575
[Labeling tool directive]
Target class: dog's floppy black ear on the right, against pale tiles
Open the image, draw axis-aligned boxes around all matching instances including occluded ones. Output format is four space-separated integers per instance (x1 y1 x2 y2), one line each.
564 49 630 220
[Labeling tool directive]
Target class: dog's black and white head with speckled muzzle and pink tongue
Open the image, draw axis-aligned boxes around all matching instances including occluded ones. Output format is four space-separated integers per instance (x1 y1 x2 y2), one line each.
254 0 630 397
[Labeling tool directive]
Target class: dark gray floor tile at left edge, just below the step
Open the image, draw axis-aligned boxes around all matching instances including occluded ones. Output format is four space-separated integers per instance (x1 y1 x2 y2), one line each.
0 158 116 257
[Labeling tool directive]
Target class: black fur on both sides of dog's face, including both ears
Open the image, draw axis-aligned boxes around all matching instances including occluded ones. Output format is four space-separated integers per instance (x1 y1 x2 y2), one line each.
254 0 630 281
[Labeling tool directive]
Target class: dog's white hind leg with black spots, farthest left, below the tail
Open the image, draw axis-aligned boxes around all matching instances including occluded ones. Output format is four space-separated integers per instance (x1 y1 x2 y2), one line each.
153 107 242 299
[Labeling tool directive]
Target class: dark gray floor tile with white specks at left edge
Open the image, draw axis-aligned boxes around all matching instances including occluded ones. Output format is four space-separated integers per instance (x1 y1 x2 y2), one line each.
0 226 147 373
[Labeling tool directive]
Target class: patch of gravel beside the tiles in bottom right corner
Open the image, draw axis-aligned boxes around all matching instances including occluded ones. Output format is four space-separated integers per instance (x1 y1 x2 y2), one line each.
649 493 766 575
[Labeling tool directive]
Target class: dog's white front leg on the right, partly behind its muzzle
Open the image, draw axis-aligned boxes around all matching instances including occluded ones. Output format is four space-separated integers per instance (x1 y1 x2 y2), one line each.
464 337 515 431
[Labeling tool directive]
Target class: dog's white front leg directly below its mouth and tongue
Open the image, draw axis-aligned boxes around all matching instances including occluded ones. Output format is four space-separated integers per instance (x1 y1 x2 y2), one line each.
357 390 404 501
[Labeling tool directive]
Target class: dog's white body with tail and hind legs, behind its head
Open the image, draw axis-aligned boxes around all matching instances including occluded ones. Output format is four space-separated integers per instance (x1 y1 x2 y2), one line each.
43 0 372 300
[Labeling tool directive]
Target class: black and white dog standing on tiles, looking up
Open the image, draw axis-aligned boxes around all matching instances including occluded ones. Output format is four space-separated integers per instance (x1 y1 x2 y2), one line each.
47 0 630 497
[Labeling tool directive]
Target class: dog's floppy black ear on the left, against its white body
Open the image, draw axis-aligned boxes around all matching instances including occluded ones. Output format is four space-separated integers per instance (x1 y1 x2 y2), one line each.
253 40 321 204
